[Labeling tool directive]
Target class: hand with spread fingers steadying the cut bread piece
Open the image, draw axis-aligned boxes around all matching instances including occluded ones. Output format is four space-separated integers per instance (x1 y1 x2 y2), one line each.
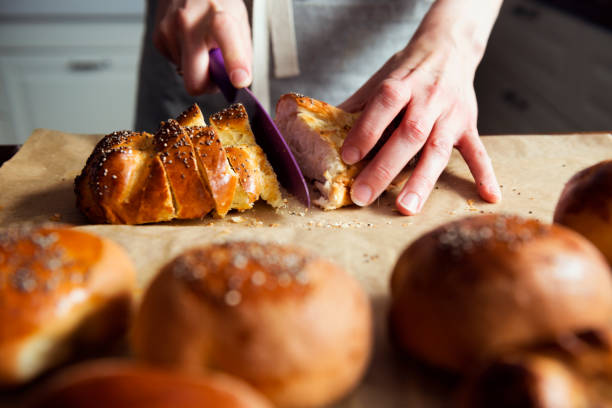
340 0 501 215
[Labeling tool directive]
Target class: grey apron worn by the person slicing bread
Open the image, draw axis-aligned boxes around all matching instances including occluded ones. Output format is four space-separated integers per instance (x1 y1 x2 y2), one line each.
135 0 432 132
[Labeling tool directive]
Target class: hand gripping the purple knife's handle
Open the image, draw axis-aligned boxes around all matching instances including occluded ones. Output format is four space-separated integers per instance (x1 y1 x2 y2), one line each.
153 0 253 96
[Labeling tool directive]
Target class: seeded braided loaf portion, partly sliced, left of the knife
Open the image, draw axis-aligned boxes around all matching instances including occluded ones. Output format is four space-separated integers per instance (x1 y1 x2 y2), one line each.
75 104 283 224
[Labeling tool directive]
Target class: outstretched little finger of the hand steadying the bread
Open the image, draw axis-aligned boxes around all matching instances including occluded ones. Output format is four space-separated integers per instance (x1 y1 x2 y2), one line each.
457 130 502 203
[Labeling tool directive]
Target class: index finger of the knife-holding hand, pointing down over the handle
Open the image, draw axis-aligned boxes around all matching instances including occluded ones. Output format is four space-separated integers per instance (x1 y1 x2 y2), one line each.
211 10 252 88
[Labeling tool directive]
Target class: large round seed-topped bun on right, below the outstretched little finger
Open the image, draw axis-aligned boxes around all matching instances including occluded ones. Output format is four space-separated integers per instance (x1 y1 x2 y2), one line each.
390 215 612 371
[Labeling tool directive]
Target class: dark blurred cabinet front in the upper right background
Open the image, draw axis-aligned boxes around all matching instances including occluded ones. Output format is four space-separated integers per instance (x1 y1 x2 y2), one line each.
475 0 612 134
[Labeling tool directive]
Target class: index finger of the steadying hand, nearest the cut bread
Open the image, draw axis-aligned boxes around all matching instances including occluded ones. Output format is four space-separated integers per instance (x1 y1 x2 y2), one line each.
342 79 410 164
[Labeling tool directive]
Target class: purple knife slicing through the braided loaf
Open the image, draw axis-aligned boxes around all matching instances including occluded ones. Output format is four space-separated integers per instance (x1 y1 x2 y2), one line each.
209 48 310 207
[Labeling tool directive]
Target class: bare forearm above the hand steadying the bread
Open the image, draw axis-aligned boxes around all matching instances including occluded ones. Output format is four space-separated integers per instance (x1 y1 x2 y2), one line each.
412 0 502 70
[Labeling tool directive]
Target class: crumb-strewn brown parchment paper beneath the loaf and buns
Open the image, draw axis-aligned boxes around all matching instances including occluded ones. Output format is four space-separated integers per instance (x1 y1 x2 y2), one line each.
0 129 612 407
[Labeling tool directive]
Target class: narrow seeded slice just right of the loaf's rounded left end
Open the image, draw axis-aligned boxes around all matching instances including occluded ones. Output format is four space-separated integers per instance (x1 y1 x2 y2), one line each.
155 119 214 219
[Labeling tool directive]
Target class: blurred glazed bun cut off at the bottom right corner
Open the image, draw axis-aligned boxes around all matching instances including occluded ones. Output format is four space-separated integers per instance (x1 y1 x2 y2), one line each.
458 329 612 408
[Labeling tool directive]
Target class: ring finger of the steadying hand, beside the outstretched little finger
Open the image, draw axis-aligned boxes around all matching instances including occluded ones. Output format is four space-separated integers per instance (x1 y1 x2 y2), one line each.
395 120 455 215
